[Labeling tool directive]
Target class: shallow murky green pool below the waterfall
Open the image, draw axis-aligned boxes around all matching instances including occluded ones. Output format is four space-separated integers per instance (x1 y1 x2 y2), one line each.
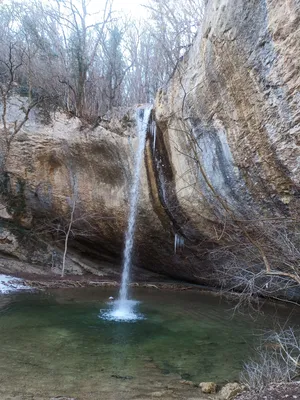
0 289 297 400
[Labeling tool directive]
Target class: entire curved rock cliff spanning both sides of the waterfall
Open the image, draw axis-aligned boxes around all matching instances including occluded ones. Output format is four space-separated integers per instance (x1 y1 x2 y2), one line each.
0 0 300 290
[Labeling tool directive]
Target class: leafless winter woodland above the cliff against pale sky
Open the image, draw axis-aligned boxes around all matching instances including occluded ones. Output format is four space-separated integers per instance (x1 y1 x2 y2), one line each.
0 0 203 122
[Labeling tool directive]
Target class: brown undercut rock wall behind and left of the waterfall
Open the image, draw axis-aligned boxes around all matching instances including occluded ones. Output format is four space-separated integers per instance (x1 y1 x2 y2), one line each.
0 106 192 275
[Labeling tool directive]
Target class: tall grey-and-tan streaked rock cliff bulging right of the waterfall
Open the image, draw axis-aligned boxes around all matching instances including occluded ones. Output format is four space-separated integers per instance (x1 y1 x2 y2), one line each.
155 0 300 286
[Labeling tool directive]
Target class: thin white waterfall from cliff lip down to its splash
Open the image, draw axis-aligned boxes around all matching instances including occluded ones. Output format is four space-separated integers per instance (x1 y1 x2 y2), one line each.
102 106 152 321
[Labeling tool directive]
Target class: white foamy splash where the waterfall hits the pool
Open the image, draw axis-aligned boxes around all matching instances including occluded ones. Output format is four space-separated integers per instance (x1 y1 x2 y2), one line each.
99 300 145 322
